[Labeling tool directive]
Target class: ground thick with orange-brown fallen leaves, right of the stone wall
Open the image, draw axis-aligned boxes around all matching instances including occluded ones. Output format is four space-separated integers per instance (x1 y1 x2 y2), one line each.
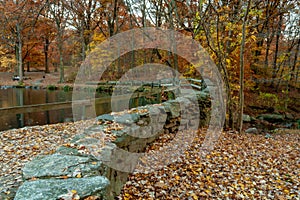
119 130 300 199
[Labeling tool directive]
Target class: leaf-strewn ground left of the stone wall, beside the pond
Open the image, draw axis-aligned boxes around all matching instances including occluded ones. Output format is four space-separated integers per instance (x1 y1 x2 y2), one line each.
0 121 86 199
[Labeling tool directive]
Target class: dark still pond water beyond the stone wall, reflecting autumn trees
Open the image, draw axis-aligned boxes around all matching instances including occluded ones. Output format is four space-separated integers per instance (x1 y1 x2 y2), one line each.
0 88 160 131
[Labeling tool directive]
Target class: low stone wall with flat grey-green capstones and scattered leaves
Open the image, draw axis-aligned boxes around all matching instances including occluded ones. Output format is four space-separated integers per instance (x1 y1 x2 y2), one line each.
15 92 211 200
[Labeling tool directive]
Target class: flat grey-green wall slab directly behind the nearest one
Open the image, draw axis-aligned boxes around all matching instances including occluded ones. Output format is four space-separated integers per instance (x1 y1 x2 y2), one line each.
23 154 102 179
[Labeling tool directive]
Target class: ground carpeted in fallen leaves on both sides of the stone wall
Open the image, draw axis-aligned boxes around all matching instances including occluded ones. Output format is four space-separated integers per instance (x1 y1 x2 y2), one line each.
0 122 300 199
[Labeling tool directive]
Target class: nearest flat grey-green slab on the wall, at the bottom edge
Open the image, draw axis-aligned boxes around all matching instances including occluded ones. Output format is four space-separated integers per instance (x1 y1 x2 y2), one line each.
14 176 109 200
